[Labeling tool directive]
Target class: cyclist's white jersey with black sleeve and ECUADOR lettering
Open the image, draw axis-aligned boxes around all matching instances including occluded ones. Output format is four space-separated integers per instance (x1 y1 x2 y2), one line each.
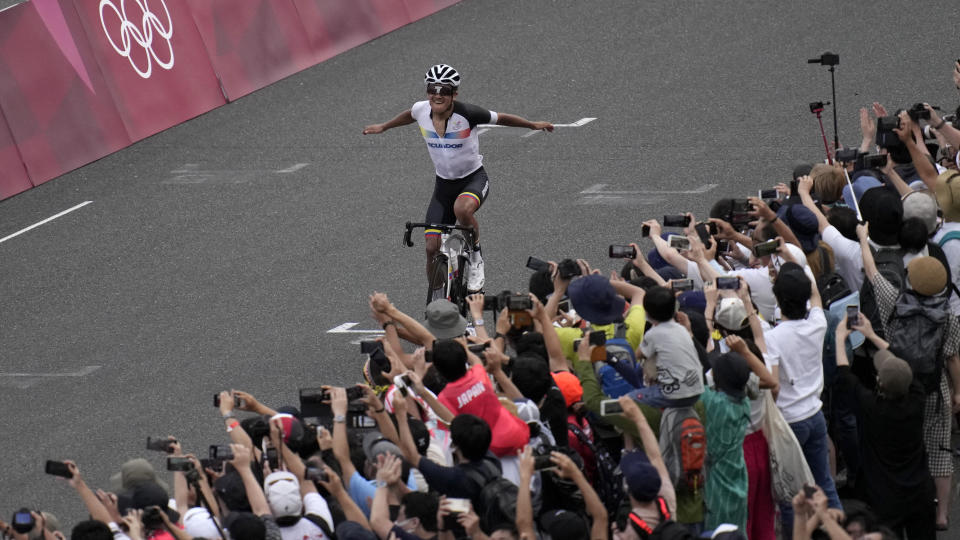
410 101 497 180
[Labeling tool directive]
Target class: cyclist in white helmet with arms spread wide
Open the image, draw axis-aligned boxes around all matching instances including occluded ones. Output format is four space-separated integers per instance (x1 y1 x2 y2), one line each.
363 64 553 292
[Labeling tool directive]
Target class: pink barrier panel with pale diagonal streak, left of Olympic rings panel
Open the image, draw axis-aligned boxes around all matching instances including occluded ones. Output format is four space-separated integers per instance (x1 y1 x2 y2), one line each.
0 0 130 185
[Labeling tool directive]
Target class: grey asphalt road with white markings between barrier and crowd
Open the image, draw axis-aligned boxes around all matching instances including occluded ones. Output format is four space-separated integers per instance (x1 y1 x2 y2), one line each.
0 0 958 526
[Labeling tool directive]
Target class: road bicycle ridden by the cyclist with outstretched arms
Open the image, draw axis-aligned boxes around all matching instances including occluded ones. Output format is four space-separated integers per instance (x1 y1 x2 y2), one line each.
403 221 476 314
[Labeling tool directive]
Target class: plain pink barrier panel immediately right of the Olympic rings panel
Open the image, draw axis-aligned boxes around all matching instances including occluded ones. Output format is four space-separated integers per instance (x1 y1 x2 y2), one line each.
190 0 315 101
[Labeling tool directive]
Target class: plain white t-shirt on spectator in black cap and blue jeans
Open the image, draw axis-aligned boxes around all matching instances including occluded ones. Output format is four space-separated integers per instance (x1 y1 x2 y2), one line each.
764 307 827 423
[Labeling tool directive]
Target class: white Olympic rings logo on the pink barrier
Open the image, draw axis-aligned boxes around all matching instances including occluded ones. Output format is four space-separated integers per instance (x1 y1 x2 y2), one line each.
100 0 173 79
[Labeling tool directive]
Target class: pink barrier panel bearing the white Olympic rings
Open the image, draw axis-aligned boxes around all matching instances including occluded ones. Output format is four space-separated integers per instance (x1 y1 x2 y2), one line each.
74 0 226 141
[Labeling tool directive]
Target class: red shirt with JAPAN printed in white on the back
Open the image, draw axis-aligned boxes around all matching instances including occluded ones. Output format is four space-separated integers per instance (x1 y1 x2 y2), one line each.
437 364 530 457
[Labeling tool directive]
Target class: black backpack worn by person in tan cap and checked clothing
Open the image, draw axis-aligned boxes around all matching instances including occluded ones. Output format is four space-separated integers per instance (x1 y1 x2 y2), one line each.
886 290 950 393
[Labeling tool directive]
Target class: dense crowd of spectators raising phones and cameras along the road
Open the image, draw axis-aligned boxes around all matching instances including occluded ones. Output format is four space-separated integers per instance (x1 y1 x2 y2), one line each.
0 62 960 540
